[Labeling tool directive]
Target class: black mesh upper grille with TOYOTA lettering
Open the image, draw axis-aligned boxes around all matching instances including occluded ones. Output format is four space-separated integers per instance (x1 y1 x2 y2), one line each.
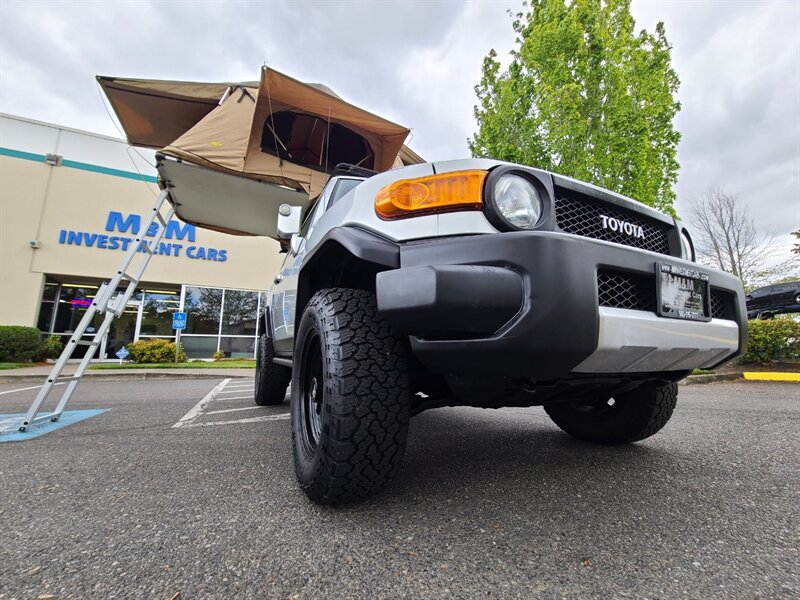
555 189 671 256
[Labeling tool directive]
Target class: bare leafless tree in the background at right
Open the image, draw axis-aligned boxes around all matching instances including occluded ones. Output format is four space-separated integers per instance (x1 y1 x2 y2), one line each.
692 188 772 285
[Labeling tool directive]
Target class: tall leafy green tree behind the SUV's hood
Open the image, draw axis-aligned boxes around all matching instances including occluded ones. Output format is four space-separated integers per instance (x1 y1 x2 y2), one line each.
469 0 680 214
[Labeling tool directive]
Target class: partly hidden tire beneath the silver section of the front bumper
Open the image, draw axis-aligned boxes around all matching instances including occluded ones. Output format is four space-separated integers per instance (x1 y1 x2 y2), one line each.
544 383 678 445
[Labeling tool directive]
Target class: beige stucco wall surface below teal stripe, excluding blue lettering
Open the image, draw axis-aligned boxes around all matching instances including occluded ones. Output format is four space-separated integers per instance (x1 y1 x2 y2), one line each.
0 156 284 325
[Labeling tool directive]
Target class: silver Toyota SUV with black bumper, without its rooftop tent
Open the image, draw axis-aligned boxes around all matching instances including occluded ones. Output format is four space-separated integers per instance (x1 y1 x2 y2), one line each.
255 159 746 504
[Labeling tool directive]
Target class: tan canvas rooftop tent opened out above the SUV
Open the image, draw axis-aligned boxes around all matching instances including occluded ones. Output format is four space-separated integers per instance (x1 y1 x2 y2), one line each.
98 67 423 237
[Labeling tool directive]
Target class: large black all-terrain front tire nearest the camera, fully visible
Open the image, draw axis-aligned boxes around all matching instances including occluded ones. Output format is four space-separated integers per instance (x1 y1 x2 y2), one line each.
291 288 411 504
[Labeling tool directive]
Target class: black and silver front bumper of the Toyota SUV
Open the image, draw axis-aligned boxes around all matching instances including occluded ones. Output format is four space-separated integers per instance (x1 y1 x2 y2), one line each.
376 231 746 379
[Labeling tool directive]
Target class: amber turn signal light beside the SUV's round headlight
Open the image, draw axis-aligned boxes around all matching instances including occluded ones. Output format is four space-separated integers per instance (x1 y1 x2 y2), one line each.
375 171 487 219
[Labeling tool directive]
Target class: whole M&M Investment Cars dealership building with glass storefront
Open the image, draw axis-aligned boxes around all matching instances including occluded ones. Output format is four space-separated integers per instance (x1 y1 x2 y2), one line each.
0 114 282 359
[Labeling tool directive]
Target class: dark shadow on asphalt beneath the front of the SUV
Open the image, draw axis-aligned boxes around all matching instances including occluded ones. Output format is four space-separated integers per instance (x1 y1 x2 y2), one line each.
360 408 686 511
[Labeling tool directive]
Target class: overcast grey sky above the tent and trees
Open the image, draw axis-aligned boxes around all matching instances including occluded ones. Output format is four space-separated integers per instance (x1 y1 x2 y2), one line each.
0 0 800 256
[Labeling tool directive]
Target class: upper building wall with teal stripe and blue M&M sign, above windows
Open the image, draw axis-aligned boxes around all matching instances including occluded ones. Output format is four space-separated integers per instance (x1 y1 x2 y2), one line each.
0 115 283 326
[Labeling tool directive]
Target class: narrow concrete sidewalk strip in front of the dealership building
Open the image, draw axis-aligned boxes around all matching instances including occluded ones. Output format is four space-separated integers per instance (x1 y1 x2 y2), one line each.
0 363 256 383
